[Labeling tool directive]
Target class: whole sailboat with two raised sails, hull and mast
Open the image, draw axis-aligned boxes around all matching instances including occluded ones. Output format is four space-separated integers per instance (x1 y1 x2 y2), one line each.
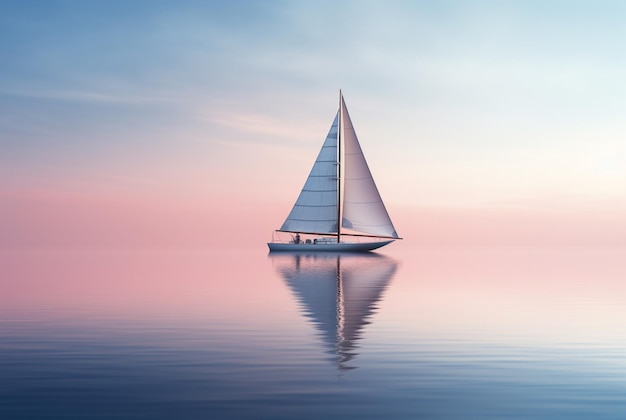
267 91 401 252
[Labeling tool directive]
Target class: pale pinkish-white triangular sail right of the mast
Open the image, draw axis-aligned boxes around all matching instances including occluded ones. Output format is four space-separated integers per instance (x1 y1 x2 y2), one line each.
340 97 398 238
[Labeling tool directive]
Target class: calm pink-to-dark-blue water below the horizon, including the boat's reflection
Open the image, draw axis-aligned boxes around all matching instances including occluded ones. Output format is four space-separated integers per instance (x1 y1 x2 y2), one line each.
0 245 626 419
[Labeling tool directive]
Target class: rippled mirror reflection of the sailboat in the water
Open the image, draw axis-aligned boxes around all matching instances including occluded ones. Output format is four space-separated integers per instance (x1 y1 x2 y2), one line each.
270 253 398 371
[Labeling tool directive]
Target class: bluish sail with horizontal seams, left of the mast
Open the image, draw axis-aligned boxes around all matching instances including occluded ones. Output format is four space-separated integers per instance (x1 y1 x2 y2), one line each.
280 113 339 233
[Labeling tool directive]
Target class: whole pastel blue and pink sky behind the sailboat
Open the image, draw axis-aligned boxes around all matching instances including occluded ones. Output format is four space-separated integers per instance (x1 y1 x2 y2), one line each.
0 0 626 249
